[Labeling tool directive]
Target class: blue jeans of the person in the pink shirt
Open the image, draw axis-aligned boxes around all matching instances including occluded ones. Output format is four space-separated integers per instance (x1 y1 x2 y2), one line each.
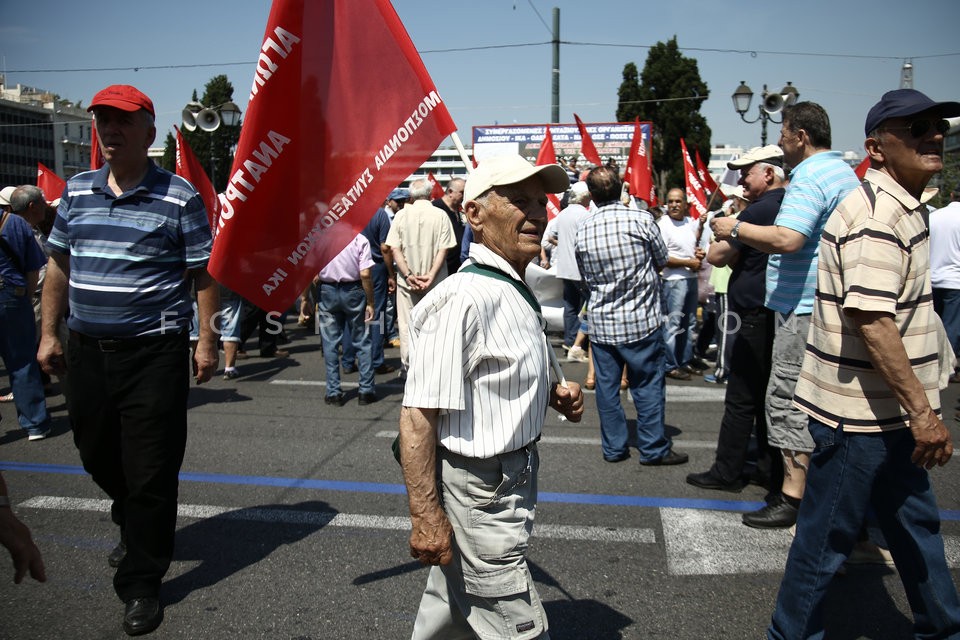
318 282 373 396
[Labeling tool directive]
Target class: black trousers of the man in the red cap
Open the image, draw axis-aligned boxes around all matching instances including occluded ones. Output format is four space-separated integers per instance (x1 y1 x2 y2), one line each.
67 333 190 601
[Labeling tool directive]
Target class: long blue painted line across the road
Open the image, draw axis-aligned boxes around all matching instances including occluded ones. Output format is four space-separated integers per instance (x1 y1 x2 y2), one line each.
7 461 960 521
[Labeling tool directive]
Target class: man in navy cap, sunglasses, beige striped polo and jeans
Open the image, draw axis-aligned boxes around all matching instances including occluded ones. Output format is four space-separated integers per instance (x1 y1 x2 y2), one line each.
767 89 960 639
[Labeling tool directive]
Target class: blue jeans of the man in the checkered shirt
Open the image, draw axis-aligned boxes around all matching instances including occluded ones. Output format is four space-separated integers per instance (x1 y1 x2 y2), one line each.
593 330 672 462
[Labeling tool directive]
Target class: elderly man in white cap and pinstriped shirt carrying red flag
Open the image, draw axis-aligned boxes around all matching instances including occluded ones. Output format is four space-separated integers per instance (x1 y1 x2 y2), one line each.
400 155 583 639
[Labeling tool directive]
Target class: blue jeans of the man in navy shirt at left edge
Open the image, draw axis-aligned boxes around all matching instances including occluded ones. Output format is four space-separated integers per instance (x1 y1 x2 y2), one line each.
0 289 50 435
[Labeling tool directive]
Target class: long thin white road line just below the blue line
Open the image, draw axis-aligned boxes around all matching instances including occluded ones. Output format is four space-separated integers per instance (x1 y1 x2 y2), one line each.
19 496 657 544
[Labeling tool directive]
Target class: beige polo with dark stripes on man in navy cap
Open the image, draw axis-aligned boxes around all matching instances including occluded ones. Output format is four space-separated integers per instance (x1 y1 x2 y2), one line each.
794 169 940 433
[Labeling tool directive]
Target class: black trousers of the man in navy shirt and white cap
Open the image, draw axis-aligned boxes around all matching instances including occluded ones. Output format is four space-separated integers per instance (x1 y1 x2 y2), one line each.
711 307 783 487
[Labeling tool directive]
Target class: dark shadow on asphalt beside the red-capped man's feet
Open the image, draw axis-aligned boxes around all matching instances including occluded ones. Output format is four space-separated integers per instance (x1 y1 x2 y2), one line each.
163 500 337 604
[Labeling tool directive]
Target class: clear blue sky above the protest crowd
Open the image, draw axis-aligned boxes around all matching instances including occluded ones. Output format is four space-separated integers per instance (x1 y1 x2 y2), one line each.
0 0 960 159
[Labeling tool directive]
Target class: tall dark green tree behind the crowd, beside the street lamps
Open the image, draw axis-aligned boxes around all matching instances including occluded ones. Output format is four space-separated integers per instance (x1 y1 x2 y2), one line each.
617 36 710 199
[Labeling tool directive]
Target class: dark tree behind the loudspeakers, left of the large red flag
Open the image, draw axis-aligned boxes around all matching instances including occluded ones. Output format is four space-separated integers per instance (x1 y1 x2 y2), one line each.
163 75 241 193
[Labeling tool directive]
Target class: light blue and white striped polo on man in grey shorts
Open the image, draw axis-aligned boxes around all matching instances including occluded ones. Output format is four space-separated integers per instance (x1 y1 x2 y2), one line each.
765 151 860 315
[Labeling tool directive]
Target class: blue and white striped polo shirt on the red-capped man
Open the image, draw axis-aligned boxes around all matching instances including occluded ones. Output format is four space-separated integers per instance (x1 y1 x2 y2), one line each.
47 162 213 337
